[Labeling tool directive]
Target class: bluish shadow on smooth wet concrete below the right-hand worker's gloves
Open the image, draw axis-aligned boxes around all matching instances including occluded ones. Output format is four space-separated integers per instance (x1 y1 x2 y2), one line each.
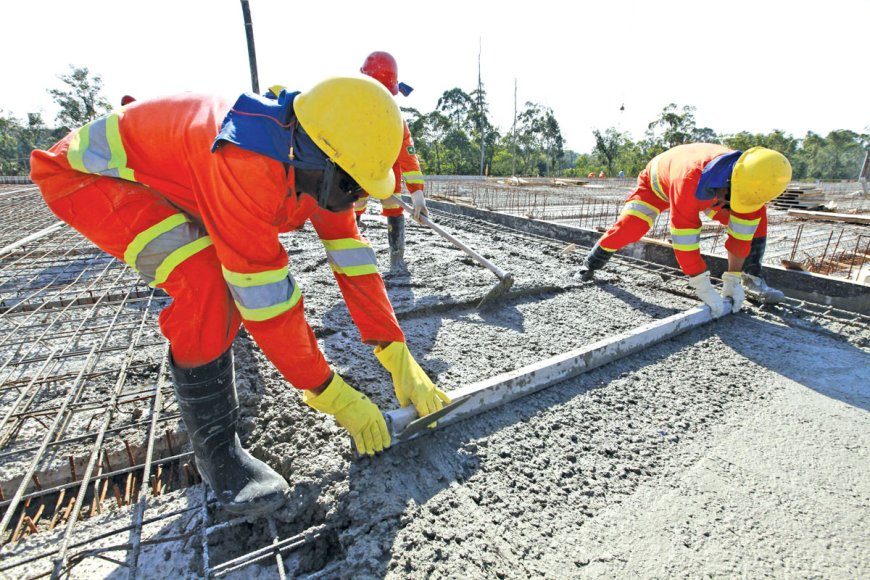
717 313 870 411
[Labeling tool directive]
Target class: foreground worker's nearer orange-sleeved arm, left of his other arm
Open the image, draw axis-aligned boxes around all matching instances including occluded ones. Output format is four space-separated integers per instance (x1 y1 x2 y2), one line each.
200 145 332 389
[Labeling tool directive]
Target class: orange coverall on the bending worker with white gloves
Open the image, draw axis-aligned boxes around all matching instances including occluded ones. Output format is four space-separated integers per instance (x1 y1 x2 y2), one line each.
598 143 767 276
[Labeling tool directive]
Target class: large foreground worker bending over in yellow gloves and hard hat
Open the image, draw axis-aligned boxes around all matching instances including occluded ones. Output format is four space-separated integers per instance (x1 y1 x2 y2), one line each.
31 77 448 514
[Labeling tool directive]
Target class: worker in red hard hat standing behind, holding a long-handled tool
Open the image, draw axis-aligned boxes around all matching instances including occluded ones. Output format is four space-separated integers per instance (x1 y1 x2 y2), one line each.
353 51 429 268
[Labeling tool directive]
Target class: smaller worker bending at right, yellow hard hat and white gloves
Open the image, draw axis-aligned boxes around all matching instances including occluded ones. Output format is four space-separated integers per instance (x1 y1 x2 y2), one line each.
579 143 791 316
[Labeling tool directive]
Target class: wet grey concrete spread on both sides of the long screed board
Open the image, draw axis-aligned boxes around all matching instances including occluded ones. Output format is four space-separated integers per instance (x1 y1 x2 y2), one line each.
3 207 870 578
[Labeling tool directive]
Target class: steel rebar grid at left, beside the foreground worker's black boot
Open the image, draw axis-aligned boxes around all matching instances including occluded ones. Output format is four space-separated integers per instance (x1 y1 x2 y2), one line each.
0 196 325 578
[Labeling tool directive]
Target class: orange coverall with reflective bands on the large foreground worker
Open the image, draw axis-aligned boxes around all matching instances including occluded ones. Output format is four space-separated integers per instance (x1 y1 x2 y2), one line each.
31 93 404 389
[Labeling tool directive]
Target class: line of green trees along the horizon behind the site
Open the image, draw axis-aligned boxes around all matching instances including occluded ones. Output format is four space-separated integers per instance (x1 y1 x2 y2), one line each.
0 65 870 180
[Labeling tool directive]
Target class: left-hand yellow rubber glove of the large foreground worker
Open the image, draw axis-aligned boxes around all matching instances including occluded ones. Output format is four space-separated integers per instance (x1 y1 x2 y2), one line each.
302 373 390 455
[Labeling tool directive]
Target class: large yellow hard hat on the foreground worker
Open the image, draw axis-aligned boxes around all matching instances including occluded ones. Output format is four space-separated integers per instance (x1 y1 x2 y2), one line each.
293 77 403 199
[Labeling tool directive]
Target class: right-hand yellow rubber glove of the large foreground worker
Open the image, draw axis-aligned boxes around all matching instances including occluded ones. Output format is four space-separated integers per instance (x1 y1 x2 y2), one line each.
375 342 450 417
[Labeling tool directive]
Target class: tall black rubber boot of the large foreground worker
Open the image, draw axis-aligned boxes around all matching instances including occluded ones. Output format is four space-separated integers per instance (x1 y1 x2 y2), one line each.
169 349 289 514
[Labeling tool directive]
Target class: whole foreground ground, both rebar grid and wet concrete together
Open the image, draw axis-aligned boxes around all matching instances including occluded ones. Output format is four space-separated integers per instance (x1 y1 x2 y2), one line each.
0 186 870 578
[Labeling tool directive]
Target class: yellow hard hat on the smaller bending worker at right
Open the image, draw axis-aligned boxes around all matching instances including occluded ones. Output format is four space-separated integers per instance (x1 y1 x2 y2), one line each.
731 147 791 213
